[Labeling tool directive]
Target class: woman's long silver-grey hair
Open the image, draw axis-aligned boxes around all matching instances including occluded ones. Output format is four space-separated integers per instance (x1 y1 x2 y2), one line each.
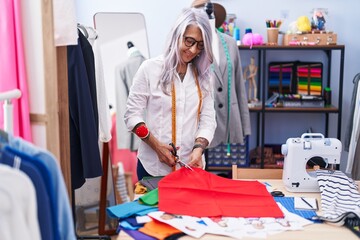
160 8 213 94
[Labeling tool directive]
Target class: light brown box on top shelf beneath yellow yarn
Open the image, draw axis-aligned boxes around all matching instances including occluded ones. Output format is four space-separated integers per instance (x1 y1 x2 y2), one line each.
283 33 337 46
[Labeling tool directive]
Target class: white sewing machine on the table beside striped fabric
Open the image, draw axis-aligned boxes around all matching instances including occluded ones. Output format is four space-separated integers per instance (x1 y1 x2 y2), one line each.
281 133 342 192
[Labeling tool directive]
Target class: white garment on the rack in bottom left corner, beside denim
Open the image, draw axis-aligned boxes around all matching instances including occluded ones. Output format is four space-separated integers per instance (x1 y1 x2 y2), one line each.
0 165 40 240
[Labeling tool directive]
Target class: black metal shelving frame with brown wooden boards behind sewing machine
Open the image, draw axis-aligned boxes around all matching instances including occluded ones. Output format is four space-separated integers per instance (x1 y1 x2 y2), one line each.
238 44 345 168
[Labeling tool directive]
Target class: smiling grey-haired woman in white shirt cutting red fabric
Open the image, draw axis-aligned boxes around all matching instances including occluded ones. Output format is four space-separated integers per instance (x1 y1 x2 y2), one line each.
124 8 216 179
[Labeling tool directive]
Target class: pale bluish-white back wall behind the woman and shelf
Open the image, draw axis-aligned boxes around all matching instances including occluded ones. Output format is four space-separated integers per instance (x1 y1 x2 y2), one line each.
76 0 360 172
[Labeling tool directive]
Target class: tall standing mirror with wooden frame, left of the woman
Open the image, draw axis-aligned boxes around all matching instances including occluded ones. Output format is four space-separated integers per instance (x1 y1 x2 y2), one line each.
93 12 149 235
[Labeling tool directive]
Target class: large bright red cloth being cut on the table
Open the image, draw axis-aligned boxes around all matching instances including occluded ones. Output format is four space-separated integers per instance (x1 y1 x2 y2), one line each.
159 168 284 218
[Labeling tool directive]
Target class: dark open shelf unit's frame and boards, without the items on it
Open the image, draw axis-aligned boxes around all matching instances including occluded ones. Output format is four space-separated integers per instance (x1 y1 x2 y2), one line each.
239 45 345 168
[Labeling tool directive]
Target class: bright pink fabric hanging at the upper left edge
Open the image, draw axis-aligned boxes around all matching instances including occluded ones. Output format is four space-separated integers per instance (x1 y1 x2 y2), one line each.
0 0 32 141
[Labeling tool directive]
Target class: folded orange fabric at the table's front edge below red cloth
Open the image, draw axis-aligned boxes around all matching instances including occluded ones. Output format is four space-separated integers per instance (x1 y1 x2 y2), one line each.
139 220 181 239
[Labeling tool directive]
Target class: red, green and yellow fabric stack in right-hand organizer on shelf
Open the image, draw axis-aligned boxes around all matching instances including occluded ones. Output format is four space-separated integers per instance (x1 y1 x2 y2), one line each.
297 64 322 96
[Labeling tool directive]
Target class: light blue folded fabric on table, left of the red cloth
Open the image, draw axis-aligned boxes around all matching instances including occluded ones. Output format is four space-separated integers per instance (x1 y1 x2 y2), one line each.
106 201 158 219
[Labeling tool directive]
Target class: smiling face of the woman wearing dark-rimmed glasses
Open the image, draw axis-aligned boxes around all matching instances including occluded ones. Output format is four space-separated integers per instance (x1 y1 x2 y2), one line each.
180 25 204 63
